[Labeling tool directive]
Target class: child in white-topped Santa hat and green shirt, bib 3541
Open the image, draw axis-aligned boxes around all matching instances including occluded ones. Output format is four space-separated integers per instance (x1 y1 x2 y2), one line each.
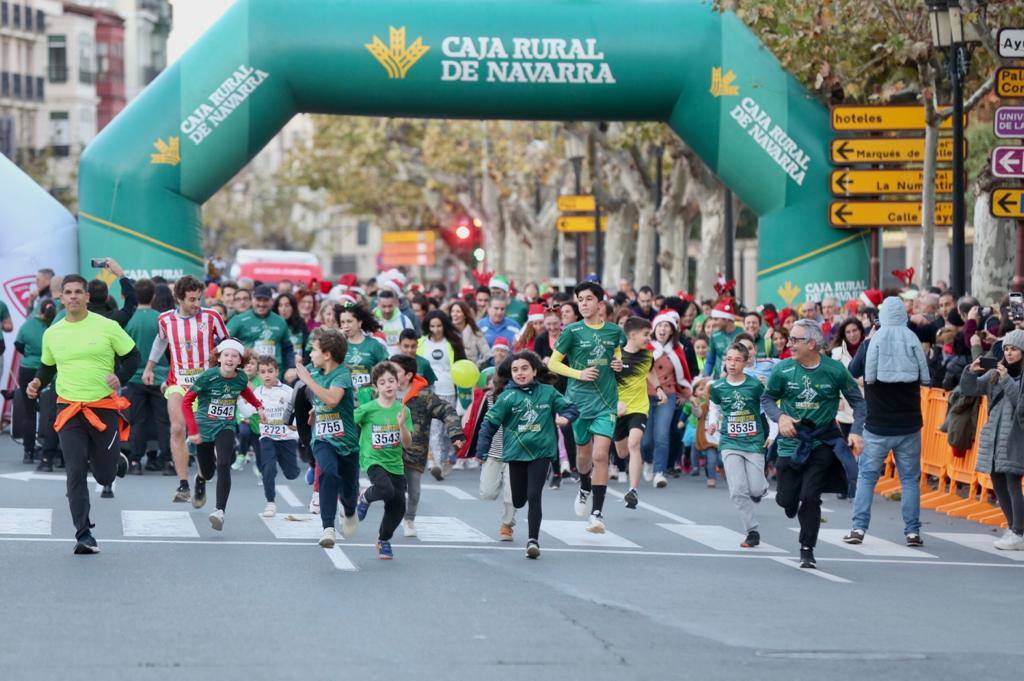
181 338 266 530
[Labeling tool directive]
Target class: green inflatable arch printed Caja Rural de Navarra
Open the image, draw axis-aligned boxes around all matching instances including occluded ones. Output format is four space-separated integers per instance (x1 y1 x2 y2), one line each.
79 0 867 302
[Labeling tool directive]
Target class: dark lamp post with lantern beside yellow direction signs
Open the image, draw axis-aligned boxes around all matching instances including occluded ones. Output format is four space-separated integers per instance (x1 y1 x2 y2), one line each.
926 0 967 294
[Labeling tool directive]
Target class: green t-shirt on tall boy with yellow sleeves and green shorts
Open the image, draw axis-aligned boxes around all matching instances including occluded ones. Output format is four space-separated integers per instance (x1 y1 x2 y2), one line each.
555 322 626 419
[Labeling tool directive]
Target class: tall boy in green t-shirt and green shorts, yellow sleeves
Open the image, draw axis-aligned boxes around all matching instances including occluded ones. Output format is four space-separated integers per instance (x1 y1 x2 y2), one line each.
548 282 626 535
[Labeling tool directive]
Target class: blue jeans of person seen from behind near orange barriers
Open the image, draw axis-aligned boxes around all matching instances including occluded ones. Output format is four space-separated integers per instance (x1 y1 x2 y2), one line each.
853 430 921 535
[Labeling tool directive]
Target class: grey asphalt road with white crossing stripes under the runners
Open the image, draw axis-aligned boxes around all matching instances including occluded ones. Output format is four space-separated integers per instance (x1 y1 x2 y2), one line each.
0 436 1024 681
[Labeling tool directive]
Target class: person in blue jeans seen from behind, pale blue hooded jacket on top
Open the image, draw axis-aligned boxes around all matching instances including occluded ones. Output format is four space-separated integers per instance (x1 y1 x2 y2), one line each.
843 297 931 546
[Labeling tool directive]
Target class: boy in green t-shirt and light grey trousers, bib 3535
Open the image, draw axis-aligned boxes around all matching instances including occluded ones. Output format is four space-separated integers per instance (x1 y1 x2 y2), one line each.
708 343 768 549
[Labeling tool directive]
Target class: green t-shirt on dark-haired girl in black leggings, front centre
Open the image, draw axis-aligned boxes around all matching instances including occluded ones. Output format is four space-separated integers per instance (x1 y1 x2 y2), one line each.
484 382 573 461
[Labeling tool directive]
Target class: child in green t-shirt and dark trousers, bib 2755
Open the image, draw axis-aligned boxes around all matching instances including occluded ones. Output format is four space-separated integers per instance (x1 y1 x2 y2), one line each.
296 328 359 549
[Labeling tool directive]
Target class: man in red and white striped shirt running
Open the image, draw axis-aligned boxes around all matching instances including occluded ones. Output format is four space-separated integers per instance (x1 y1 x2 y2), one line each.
142 275 227 503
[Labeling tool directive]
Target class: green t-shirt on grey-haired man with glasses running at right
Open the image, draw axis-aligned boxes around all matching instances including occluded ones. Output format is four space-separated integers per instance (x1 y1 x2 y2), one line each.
765 355 860 457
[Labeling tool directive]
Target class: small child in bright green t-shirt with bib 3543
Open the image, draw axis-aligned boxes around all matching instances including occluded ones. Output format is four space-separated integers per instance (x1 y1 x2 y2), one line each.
354 361 413 560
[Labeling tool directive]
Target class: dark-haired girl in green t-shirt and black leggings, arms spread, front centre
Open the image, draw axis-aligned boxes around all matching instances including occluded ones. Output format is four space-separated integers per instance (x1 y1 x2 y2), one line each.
476 351 580 558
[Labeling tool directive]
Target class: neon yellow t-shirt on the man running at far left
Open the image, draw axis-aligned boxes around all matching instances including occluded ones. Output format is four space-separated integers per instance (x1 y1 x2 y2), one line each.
40 312 135 402
